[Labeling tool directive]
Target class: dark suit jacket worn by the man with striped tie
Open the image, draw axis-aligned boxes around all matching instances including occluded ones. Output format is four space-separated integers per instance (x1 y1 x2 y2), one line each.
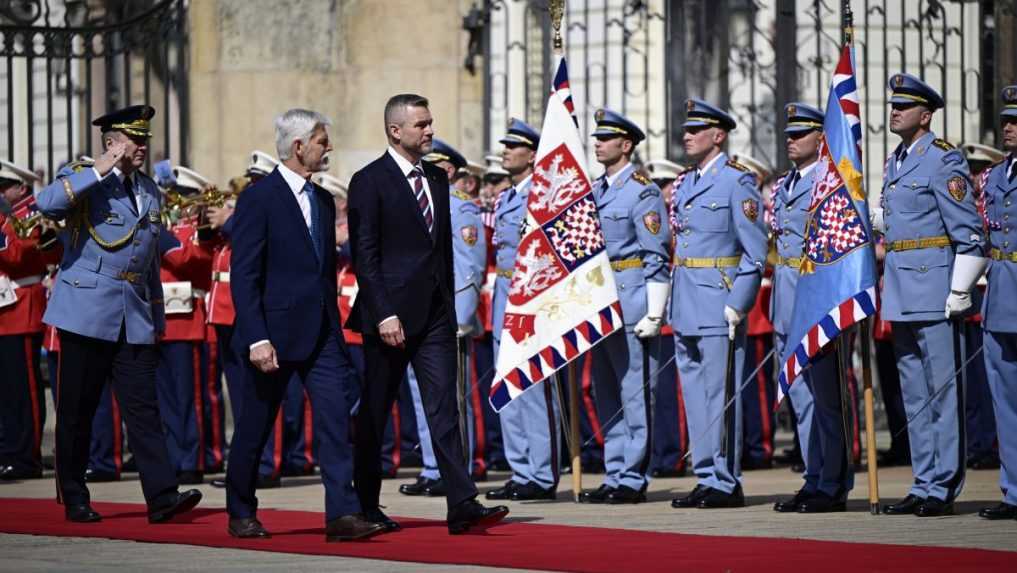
347 152 455 336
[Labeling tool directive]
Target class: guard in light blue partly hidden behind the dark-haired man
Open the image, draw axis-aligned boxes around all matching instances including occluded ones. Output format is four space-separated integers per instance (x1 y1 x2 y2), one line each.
399 138 487 497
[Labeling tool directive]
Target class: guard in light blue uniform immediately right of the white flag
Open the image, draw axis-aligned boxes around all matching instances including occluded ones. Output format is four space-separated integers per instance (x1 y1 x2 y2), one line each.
580 109 671 504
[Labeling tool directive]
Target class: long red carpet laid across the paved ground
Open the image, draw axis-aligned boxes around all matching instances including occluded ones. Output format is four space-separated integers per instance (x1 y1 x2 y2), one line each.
0 499 1017 573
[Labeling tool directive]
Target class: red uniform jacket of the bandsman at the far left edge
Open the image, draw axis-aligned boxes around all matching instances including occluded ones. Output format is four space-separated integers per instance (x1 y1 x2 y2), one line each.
0 215 63 336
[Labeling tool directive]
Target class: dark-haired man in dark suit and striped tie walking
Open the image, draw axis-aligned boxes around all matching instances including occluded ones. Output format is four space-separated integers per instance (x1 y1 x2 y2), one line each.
348 94 509 533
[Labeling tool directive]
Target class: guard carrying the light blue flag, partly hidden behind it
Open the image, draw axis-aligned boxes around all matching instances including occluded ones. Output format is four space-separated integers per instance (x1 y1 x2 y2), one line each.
769 103 854 513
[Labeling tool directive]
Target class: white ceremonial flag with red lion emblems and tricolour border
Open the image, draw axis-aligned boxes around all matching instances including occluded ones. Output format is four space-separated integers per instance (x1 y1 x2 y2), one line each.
490 57 623 411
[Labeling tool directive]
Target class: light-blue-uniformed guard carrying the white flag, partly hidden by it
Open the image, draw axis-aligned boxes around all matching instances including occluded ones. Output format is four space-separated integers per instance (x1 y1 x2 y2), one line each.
486 119 561 501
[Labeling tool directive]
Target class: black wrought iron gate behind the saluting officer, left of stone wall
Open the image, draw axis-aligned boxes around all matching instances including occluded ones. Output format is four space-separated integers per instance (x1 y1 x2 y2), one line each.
0 0 188 179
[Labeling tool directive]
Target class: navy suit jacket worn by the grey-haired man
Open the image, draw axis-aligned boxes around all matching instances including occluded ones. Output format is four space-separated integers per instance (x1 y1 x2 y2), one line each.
230 169 339 361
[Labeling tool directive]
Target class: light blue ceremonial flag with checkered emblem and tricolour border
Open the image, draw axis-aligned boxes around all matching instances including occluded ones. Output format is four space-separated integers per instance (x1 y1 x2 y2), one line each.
778 45 877 403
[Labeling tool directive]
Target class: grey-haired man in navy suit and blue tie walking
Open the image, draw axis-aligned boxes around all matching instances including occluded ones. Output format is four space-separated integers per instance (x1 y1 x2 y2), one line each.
226 109 384 541
